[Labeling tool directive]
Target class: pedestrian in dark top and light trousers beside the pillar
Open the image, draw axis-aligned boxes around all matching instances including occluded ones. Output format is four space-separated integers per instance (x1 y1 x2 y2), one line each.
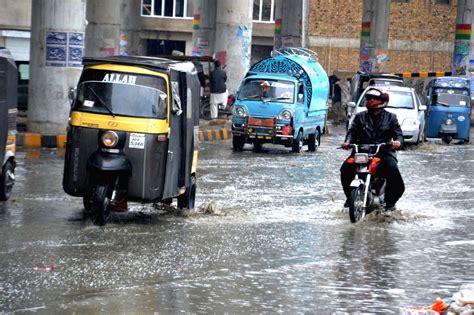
209 60 228 119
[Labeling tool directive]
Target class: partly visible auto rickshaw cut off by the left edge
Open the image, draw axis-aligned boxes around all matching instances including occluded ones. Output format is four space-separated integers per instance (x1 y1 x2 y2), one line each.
0 49 18 201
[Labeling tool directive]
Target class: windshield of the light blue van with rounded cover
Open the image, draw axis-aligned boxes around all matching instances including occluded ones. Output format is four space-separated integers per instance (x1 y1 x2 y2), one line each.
239 79 295 103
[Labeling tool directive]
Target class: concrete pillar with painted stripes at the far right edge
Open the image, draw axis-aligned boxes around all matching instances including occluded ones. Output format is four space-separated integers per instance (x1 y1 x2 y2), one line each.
452 0 474 77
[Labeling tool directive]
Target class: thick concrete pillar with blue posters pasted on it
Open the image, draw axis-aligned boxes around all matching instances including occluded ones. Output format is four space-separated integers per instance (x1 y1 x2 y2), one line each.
28 0 86 135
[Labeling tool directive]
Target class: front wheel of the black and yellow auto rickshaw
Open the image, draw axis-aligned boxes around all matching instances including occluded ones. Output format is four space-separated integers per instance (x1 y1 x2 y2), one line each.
90 181 112 226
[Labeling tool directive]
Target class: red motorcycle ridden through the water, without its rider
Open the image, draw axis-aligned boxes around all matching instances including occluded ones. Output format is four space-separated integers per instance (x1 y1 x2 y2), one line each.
346 143 391 223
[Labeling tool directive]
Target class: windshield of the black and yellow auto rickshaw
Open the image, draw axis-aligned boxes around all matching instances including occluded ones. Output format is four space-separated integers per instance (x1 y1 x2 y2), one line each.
73 81 167 118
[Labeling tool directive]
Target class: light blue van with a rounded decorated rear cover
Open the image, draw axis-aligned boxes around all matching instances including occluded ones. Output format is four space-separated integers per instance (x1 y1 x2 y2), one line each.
232 48 329 153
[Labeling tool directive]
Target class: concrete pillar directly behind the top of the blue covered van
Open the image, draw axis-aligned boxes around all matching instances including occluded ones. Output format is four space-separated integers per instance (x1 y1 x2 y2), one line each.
274 0 309 48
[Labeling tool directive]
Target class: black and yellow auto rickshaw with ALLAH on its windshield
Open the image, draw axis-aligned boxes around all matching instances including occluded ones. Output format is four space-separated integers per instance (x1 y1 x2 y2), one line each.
63 56 200 225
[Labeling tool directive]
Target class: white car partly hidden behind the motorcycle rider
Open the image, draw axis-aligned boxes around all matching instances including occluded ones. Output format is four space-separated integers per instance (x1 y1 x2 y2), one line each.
347 86 426 144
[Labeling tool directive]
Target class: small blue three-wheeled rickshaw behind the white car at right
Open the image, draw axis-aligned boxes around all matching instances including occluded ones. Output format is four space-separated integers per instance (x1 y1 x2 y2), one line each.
426 77 472 143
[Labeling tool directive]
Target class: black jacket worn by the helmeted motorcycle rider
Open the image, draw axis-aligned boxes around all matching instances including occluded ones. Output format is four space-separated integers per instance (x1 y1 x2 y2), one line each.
345 110 403 157
